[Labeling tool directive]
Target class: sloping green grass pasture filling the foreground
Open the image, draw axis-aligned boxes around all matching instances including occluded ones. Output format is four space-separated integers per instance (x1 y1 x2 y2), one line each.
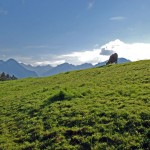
0 60 150 150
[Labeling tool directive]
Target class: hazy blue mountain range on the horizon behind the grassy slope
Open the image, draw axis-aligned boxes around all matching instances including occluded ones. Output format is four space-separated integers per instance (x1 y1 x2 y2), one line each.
0 58 130 78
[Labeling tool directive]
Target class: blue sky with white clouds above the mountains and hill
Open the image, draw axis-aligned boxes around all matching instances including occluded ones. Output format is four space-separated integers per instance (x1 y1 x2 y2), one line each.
0 0 150 66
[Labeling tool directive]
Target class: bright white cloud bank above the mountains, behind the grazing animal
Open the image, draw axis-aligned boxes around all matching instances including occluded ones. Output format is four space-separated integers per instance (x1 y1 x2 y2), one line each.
32 39 150 66
